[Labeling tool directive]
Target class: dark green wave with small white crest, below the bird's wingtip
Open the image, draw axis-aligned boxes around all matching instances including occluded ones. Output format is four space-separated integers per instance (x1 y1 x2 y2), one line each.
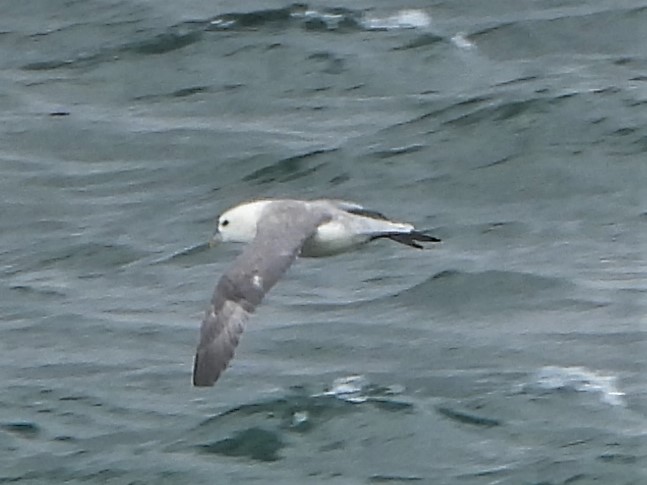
180 376 413 462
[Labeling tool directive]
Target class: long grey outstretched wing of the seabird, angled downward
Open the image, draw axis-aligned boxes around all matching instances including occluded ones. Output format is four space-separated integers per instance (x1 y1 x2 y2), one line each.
193 202 328 386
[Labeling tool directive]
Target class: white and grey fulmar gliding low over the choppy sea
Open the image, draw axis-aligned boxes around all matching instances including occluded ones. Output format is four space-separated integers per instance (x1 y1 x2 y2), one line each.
193 199 440 386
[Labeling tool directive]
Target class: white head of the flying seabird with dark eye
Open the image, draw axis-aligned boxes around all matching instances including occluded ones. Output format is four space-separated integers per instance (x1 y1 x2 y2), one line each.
211 200 270 245
